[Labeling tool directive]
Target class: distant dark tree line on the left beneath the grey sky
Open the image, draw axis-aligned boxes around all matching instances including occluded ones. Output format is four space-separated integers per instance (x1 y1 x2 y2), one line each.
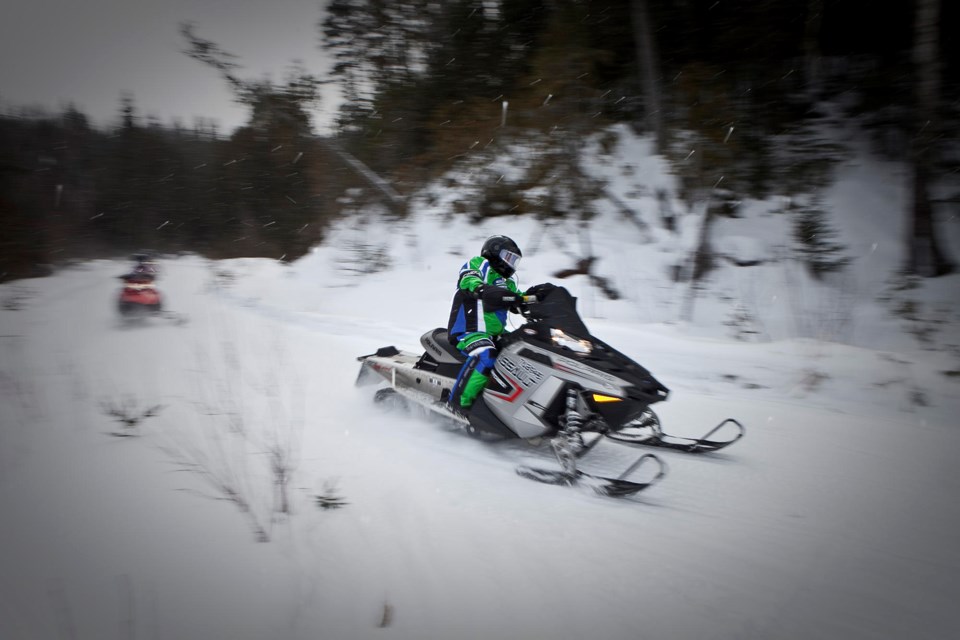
0 103 348 277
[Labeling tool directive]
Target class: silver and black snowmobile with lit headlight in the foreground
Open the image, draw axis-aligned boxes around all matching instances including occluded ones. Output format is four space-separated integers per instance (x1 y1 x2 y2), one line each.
357 286 744 497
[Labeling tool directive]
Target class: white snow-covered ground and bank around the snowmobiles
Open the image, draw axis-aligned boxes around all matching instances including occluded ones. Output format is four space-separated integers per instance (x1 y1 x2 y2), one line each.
0 127 960 640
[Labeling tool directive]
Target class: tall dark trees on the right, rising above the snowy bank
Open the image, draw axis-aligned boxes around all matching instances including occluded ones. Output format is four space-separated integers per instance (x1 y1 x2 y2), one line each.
322 0 960 276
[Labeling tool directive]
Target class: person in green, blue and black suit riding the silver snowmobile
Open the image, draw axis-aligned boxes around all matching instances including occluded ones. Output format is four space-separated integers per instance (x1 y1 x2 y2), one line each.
447 236 523 411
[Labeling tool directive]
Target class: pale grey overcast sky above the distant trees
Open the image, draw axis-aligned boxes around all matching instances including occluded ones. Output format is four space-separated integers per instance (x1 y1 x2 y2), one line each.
0 0 336 132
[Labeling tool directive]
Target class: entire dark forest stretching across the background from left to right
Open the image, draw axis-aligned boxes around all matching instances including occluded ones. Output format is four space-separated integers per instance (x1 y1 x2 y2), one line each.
0 0 960 281
